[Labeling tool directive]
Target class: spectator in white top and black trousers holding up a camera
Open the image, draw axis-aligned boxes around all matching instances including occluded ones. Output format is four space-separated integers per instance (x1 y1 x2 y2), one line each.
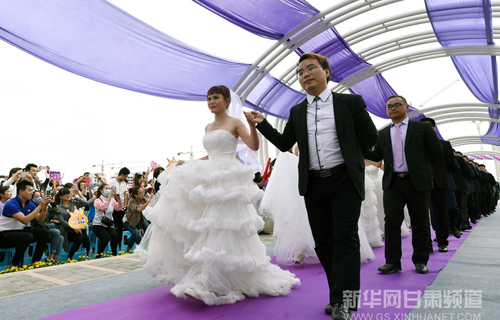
92 184 123 259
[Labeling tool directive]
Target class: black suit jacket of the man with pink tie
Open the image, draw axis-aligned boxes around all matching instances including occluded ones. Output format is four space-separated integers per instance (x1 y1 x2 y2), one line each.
365 120 443 191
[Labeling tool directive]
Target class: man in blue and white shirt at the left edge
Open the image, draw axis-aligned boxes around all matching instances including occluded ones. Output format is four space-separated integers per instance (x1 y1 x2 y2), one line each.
0 180 50 267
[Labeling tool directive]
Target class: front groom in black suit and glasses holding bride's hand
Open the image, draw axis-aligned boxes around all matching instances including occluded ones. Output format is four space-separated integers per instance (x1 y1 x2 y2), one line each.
246 53 377 319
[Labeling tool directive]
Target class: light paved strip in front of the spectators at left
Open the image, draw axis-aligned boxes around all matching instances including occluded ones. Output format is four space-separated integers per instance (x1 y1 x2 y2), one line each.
0 235 276 299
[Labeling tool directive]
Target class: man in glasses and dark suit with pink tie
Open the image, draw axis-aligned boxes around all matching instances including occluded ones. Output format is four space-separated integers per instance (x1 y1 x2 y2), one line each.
366 96 443 273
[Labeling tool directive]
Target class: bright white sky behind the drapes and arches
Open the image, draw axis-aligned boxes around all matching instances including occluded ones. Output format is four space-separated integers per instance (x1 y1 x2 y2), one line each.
0 0 495 182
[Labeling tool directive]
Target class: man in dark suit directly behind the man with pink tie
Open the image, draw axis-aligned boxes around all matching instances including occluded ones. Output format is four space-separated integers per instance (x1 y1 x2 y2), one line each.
419 118 455 252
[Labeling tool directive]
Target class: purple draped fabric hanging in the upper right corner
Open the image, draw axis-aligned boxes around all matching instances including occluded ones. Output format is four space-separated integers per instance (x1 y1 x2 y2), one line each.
425 0 500 144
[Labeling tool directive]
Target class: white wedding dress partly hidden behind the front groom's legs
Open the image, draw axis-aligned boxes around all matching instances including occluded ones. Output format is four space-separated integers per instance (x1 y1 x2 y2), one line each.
259 152 375 265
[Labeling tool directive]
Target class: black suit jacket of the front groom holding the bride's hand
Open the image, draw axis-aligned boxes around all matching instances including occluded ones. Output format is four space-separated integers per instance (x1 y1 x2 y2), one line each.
257 92 377 199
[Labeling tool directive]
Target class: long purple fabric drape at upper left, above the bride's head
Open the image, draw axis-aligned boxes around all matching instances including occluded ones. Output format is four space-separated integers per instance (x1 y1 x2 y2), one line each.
0 0 304 118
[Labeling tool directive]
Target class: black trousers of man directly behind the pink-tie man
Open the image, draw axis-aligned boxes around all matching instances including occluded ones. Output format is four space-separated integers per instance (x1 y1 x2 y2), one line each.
429 187 449 246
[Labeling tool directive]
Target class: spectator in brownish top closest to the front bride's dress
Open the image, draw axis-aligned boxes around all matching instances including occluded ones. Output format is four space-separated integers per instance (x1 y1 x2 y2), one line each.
123 186 152 252
